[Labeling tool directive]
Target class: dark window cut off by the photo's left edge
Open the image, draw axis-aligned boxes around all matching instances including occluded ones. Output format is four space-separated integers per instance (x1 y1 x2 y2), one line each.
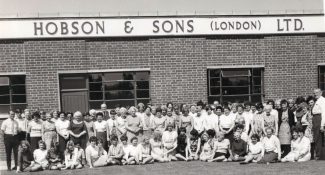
0 75 27 115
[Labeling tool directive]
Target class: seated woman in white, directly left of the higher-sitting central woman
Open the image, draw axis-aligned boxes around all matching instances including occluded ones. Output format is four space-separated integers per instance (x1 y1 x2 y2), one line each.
149 131 166 162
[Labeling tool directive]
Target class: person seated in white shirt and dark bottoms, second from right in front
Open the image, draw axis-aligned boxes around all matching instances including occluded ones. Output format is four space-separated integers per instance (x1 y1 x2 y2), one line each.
258 128 281 164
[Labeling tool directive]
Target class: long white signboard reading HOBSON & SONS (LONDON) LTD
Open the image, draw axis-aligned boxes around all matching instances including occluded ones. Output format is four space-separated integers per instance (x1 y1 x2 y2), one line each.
0 16 325 39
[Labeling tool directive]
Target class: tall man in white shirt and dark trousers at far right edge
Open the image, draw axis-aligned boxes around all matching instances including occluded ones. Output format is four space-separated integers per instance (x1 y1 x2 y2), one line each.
311 89 325 160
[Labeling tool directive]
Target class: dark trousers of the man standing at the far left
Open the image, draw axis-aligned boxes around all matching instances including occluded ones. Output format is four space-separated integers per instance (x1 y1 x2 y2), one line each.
4 134 19 169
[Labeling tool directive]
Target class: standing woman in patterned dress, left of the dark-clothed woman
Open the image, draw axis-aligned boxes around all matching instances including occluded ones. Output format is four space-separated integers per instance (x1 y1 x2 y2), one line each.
279 111 291 145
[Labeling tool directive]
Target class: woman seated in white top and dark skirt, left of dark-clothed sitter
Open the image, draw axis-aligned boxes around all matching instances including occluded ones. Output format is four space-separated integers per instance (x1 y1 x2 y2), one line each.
210 132 230 162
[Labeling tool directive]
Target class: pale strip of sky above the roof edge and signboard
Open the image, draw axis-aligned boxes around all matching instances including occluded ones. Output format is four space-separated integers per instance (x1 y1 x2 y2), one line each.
0 0 323 15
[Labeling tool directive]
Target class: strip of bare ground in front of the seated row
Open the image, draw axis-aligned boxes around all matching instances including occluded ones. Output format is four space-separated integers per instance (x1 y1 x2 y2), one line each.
1 161 325 175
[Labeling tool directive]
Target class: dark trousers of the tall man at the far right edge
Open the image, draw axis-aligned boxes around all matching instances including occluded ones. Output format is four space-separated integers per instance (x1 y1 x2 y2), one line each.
313 114 323 158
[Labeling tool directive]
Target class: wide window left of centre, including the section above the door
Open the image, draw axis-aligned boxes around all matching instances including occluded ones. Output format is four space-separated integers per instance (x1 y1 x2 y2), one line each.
60 71 150 109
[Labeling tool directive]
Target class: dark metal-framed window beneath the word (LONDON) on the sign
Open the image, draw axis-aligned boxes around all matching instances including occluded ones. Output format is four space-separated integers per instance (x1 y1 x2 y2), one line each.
208 68 263 104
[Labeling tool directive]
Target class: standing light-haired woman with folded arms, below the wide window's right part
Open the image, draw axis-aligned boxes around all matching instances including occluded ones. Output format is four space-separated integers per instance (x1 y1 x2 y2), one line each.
126 106 142 142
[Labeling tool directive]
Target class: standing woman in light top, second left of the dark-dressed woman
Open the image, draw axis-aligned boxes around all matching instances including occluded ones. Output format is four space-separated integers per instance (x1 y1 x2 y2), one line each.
42 113 57 149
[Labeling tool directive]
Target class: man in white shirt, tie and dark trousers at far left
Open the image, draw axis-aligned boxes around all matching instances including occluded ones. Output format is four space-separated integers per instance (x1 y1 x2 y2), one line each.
1 111 19 171
